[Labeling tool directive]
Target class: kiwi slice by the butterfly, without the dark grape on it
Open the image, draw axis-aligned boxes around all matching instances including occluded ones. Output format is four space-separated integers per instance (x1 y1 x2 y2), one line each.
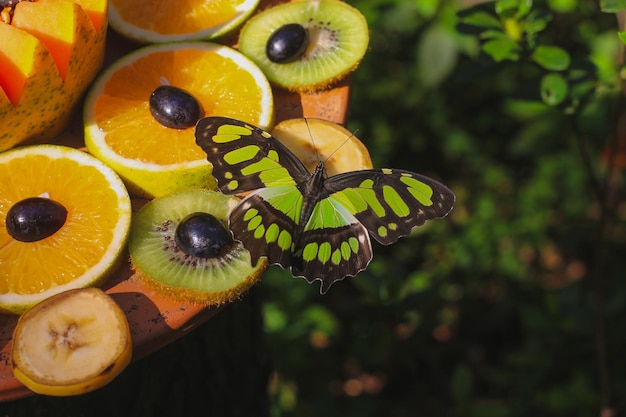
128 189 267 306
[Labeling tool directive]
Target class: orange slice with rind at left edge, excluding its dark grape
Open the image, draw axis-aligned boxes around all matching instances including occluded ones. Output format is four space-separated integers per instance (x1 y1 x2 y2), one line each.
0 145 131 314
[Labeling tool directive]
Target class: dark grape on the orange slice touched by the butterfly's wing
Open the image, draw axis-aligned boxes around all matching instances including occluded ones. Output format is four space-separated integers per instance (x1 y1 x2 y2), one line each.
150 85 204 129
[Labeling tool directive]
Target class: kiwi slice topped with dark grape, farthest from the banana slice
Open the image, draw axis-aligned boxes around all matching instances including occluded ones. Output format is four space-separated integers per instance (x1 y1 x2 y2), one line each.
239 0 369 92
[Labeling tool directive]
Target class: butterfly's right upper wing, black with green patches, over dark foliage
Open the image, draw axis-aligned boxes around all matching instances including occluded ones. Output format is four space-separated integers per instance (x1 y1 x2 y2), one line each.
324 169 455 245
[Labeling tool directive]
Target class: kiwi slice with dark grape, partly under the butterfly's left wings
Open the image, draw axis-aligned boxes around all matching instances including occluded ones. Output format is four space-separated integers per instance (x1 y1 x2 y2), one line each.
128 189 267 305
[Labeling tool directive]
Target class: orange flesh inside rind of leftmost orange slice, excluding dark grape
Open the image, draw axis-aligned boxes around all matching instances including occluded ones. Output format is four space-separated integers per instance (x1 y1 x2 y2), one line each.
0 155 118 294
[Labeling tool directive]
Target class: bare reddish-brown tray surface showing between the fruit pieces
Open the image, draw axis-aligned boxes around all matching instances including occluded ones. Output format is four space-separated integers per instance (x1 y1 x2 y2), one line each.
0 0 349 401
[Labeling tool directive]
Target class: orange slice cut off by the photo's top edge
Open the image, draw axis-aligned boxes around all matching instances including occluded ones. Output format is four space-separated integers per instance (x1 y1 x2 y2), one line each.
109 0 259 43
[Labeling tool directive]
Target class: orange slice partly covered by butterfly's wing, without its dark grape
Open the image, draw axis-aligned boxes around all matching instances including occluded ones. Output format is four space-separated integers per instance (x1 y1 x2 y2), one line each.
84 42 274 198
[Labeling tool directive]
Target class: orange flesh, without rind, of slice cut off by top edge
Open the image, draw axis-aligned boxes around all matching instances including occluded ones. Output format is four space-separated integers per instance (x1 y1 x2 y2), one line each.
113 0 238 35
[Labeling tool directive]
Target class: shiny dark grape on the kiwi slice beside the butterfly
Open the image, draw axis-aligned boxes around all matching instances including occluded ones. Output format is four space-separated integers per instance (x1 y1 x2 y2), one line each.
175 212 233 258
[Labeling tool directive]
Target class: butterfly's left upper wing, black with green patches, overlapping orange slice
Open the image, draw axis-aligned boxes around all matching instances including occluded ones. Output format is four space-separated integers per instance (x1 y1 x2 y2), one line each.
195 117 310 194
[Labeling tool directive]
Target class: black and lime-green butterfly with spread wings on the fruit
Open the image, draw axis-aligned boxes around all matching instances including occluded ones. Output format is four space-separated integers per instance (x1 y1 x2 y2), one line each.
195 117 455 294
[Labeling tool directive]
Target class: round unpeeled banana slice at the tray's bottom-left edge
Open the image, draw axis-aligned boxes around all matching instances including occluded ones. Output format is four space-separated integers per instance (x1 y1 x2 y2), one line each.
11 288 132 396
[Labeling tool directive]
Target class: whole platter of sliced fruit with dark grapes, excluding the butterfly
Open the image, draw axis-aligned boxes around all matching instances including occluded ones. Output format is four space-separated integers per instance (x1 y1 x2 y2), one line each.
0 0 371 401
